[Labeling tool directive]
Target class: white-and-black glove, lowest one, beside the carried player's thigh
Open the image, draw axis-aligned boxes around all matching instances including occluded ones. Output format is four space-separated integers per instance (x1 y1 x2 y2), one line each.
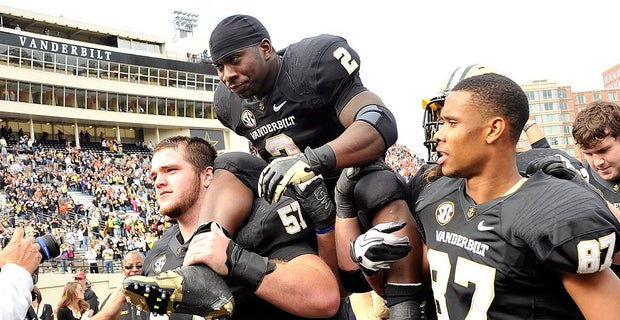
351 222 411 277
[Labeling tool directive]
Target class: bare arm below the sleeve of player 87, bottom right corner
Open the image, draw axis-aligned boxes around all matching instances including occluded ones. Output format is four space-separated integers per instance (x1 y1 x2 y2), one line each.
561 268 620 320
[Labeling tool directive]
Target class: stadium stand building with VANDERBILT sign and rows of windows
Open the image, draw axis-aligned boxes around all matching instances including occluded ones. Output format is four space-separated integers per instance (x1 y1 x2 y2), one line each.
0 6 249 151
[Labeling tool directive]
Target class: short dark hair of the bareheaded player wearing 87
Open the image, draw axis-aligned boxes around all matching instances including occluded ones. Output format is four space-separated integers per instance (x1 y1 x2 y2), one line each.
452 73 530 144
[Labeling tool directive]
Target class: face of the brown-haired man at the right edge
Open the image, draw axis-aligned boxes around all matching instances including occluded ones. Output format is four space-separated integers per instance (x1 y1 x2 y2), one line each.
581 136 620 181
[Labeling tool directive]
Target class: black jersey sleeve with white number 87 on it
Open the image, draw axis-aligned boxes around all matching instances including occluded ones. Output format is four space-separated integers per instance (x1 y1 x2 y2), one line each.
512 173 620 273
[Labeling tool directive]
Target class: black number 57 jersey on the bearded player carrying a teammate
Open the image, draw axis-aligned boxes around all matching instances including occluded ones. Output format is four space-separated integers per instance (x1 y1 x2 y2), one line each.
142 196 316 319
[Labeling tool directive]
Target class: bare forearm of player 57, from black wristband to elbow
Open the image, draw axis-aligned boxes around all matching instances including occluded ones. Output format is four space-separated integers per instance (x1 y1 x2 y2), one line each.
255 254 340 318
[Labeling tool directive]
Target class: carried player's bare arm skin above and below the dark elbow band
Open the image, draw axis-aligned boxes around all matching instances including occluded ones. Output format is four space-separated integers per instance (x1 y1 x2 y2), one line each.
327 91 389 169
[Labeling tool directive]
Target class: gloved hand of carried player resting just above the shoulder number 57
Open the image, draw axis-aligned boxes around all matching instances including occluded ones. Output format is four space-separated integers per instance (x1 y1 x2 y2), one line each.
258 145 336 202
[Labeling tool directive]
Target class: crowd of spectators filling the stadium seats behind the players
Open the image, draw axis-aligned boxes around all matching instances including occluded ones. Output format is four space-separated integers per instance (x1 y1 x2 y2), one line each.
0 131 424 273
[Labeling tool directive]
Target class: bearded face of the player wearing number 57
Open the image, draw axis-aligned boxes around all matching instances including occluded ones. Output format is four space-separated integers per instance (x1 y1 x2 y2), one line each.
151 148 201 218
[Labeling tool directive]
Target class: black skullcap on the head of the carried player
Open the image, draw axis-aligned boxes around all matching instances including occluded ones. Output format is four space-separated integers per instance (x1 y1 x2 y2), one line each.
209 14 270 62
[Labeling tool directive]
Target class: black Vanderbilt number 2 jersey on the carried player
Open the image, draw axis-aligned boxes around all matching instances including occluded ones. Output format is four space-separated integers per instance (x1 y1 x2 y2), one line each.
214 35 366 162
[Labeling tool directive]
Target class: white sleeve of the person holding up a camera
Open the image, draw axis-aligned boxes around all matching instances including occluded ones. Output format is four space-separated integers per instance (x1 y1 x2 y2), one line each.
0 263 34 319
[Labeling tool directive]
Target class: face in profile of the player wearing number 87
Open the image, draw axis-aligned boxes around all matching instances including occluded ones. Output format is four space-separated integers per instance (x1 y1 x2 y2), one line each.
435 91 486 178
